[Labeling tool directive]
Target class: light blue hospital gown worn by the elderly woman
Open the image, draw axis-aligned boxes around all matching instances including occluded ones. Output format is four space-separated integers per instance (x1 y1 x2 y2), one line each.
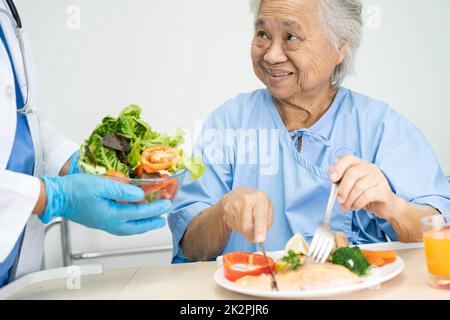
169 88 450 262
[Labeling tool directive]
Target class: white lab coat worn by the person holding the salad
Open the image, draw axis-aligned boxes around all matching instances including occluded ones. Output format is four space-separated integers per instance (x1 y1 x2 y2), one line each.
0 1 77 278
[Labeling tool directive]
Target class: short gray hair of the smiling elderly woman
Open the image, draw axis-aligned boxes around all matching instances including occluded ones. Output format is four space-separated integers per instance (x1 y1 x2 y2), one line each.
250 0 364 88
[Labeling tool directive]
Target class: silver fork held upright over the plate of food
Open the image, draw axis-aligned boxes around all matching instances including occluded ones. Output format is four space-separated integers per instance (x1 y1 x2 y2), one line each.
309 183 338 264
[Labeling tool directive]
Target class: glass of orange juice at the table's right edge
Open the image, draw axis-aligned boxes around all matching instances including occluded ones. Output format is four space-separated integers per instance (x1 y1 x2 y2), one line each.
423 228 450 278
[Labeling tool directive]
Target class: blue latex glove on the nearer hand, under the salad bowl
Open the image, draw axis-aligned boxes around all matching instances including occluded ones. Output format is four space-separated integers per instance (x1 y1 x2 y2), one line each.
40 174 172 236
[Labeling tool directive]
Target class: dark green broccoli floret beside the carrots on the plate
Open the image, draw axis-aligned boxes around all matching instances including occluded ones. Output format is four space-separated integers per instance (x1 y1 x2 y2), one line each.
331 247 370 276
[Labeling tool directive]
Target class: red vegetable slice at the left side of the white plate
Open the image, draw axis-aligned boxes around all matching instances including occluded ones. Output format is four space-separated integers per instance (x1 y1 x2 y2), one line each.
223 252 275 282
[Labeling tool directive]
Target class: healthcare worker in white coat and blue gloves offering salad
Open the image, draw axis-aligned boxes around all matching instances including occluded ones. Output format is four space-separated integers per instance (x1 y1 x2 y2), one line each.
0 0 170 288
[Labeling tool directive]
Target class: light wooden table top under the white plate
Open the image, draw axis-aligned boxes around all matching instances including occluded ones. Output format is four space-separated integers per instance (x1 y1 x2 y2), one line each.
6 245 450 300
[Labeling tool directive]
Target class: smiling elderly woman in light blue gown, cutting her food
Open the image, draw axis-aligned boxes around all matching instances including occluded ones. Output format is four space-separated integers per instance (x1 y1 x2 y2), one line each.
169 0 450 262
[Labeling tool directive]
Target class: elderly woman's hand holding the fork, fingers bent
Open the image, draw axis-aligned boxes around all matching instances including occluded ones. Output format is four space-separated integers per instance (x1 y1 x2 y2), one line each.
329 156 397 220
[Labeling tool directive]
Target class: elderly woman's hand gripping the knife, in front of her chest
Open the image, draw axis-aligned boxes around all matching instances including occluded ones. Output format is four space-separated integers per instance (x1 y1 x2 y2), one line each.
220 188 274 243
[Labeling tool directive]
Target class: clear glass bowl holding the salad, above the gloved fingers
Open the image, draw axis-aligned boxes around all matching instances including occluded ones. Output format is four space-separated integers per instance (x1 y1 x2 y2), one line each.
100 169 187 204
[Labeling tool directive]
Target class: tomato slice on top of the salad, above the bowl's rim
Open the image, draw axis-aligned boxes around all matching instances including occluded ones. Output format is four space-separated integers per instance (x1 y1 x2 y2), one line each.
141 146 180 174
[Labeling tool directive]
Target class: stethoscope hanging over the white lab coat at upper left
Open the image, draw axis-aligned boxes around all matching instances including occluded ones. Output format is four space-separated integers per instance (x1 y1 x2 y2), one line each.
0 0 34 114
